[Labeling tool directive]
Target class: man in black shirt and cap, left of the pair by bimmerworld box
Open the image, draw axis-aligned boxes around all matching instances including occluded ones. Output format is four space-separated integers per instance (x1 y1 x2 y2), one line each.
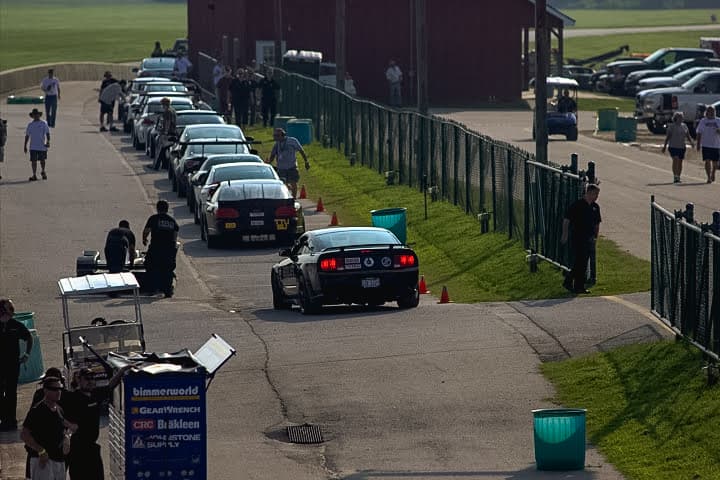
20 377 72 480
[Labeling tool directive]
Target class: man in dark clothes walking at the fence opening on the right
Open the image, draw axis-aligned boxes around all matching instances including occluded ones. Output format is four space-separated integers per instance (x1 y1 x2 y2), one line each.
560 184 600 294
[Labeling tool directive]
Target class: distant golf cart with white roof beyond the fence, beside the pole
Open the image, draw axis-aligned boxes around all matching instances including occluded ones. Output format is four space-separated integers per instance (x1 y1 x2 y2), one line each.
533 77 580 142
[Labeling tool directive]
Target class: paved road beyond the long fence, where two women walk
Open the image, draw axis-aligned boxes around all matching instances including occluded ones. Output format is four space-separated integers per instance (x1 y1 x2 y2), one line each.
433 107 720 260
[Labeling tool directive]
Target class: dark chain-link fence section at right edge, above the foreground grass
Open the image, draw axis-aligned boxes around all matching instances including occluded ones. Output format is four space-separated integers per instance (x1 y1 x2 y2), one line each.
650 198 720 360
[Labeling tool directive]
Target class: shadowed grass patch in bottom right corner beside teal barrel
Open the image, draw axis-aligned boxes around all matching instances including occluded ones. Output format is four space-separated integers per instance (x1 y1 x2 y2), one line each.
542 341 720 480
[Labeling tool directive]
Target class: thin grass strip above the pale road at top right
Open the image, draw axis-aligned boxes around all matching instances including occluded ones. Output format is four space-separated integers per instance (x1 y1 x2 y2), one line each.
562 8 720 28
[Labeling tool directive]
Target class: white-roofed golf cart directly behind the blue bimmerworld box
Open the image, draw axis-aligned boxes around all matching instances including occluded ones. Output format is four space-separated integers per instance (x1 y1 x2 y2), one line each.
58 272 145 386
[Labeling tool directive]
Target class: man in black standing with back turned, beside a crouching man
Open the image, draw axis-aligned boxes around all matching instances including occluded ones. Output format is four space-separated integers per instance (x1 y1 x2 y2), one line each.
143 200 180 298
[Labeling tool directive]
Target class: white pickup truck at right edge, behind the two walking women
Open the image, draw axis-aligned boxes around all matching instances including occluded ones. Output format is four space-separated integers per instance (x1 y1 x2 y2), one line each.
635 70 720 135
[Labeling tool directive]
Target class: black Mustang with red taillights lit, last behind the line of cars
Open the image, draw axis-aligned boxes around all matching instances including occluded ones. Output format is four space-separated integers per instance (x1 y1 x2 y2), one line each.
271 227 420 314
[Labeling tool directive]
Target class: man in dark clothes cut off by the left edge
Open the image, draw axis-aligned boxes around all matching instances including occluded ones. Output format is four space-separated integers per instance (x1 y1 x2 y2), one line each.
0 298 33 432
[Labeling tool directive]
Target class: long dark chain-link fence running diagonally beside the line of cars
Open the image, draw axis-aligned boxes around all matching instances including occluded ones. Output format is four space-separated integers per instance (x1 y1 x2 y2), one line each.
276 70 594 266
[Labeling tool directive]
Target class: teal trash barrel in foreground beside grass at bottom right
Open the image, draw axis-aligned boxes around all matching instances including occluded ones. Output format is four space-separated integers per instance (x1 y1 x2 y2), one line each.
532 408 587 470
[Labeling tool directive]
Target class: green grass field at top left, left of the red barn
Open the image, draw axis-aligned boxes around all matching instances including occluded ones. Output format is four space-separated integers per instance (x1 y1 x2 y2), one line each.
0 0 187 70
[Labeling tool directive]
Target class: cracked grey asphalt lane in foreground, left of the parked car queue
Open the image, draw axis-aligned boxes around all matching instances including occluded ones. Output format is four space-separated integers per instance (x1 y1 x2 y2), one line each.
0 82 668 480
